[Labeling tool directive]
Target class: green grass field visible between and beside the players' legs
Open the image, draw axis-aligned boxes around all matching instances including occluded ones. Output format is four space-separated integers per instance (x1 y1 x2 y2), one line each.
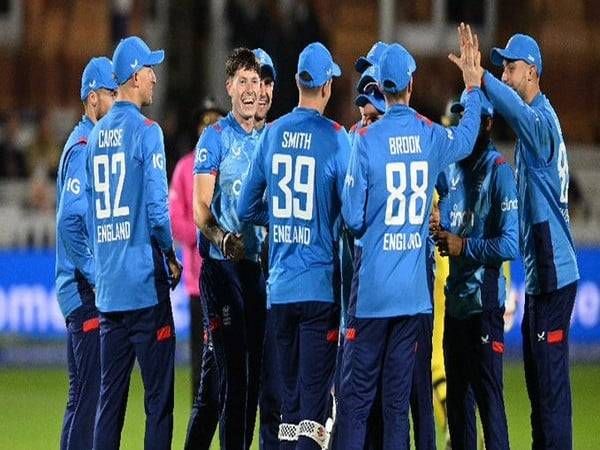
0 363 600 450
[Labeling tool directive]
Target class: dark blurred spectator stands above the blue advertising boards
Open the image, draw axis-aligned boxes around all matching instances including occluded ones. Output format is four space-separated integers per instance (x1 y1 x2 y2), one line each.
0 0 600 248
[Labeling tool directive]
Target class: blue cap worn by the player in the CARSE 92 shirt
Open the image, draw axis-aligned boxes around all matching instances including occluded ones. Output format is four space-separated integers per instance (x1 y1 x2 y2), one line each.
113 36 165 84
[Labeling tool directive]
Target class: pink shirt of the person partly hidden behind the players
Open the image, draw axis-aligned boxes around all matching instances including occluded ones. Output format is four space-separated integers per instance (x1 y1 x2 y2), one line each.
169 151 202 295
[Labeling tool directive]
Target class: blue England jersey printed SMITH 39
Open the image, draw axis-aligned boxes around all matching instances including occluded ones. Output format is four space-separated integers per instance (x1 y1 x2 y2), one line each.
238 107 350 304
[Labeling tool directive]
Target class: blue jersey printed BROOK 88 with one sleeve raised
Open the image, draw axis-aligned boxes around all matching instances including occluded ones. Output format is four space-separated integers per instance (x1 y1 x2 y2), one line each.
342 88 482 318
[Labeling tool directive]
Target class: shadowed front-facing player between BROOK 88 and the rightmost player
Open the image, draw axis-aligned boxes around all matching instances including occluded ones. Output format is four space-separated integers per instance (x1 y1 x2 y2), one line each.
434 92 519 450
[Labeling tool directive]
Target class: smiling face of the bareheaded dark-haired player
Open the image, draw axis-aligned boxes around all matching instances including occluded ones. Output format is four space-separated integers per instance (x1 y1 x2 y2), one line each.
226 68 260 121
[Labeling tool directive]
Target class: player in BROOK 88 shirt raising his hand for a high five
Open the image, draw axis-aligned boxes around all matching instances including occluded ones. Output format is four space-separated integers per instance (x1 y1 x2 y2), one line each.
338 27 482 449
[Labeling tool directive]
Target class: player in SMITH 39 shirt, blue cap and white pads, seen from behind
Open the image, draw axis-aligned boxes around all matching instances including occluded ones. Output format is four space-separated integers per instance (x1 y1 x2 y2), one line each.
238 42 350 449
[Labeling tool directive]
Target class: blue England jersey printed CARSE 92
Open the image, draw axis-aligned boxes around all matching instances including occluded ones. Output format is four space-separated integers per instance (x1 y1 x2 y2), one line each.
87 101 173 312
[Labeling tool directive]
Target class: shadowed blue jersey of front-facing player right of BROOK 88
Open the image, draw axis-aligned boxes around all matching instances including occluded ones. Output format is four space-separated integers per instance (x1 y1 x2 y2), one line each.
437 143 519 319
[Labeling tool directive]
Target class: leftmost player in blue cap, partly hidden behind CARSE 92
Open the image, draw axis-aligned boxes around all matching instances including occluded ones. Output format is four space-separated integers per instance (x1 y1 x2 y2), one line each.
56 57 117 450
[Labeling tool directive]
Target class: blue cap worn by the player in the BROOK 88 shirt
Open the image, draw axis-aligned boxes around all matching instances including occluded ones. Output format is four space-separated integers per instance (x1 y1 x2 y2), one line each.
379 44 417 94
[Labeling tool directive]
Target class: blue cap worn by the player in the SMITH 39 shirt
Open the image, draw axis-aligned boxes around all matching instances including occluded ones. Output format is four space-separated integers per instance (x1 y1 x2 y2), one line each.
297 42 342 88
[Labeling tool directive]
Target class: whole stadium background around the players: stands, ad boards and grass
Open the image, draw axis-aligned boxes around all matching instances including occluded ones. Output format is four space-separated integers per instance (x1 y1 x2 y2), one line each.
0 0 600 449
